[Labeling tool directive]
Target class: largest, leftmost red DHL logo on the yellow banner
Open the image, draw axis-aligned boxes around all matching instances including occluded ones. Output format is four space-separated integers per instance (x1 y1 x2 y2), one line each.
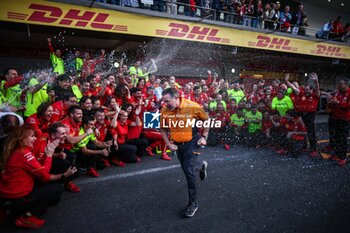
7 3 128 32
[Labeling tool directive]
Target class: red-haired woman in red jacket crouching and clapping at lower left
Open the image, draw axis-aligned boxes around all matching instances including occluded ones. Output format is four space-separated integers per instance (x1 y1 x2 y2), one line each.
0 125 76 229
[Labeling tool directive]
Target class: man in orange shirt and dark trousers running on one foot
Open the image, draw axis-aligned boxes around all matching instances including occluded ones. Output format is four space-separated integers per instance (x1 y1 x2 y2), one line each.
160 88 209 217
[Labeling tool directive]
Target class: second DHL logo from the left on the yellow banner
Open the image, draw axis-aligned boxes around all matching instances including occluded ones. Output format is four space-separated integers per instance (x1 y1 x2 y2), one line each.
156 23 230 43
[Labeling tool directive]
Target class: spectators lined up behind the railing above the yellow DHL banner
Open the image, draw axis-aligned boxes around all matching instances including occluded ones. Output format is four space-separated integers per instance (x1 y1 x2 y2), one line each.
96 0 308 35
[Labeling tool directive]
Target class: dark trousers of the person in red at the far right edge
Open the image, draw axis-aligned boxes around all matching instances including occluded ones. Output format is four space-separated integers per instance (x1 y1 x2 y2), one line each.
334 120 349 159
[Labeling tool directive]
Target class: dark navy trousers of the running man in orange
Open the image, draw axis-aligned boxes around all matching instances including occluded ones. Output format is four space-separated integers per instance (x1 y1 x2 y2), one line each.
176 136 201 204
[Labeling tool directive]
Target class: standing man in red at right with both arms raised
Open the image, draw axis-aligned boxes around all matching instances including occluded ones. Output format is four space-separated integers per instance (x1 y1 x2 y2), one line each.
286 73 320 157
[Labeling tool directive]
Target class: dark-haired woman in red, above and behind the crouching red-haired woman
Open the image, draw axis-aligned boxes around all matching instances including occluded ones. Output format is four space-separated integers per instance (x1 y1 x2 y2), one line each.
25 102 53 138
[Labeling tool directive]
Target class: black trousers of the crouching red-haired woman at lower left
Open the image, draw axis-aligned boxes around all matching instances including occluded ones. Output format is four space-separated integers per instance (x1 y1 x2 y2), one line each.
1 183 63 217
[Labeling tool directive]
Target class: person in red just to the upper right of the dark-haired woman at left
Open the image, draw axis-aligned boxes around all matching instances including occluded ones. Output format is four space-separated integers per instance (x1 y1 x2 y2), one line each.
51 94 77 122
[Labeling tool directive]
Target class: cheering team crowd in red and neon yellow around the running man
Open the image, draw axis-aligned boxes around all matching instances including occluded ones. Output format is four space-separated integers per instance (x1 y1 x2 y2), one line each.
0 38 350 228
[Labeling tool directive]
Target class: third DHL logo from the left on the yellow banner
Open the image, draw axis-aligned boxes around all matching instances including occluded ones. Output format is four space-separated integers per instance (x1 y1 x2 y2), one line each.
248 36 298 52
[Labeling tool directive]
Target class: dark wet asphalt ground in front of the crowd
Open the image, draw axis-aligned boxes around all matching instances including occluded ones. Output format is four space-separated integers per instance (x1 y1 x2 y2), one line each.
0 125 350 233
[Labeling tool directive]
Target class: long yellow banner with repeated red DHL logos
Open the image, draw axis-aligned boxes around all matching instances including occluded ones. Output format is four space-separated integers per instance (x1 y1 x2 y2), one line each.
0 0 350 59
